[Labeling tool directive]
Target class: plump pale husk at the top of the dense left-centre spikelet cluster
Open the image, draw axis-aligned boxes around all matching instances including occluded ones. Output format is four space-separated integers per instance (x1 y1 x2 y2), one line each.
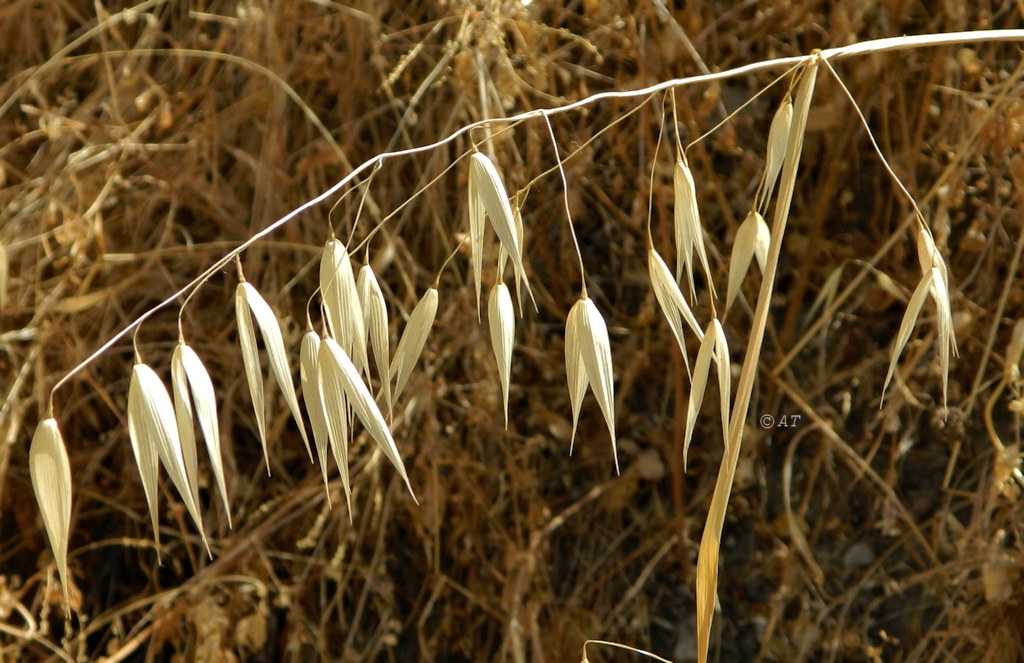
319 239 368 371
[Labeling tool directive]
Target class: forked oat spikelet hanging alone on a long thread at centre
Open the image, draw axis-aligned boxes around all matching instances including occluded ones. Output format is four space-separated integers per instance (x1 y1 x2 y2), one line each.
566 297 618 472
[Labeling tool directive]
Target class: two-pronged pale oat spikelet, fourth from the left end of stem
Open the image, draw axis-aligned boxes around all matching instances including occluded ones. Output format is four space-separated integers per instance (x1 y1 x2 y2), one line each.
234 281 313 467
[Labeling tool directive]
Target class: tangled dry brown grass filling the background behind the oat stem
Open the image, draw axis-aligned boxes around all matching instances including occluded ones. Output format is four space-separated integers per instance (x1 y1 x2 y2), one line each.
6 0 1024 662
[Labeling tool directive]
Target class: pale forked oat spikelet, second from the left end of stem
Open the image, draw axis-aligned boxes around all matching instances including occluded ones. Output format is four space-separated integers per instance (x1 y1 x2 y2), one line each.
128 363 210 554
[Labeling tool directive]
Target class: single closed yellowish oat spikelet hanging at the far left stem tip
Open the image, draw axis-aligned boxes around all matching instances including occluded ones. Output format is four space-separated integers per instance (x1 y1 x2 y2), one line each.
29 417 72 617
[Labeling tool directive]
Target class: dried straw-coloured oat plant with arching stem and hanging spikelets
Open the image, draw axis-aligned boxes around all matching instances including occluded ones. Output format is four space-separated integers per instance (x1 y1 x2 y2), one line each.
22 31 1024 662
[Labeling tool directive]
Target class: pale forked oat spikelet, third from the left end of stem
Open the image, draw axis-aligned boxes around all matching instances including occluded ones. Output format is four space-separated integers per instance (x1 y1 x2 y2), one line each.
171 341 231 527
